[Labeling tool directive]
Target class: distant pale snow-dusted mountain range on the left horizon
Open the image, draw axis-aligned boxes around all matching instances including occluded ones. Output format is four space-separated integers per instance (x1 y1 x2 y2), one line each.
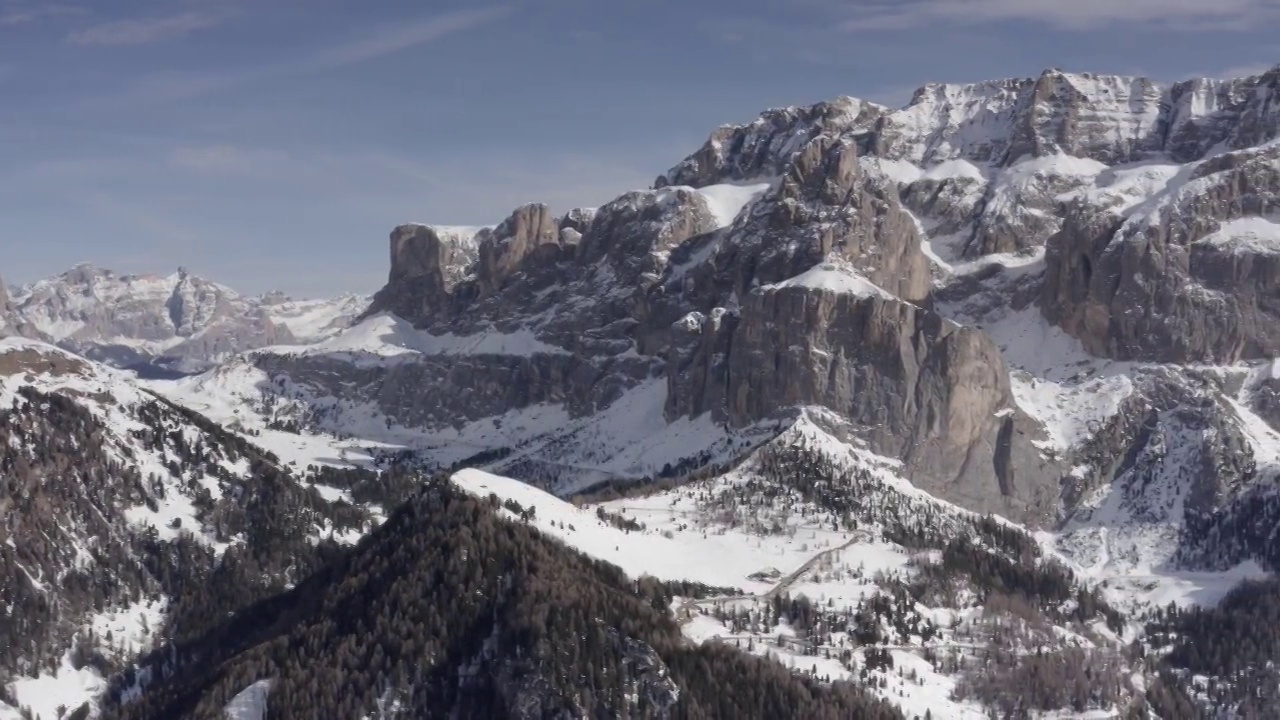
12 265 367 373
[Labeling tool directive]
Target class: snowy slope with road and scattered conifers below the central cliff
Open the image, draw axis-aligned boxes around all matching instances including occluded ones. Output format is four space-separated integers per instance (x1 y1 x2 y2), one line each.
453 411 1198 719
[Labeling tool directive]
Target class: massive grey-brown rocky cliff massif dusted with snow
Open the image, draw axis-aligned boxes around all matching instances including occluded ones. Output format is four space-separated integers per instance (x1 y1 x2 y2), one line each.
230 64 1280 523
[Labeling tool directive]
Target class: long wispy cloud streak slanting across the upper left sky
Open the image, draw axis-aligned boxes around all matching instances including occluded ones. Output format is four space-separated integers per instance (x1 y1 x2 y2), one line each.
129 5 512 100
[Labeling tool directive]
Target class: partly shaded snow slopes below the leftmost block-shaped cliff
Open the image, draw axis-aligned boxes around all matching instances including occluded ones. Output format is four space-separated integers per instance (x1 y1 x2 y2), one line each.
147 348 776 492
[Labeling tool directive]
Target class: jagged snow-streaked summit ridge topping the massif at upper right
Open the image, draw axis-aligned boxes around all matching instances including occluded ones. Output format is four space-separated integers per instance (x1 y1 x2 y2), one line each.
657 68 1280 186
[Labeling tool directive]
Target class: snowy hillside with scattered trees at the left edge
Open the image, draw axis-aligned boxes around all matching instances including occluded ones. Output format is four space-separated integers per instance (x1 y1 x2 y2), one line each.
0 337 376 720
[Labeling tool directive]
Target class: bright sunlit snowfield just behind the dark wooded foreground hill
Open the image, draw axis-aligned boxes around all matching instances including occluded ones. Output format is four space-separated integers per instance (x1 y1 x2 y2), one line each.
453 420 986 720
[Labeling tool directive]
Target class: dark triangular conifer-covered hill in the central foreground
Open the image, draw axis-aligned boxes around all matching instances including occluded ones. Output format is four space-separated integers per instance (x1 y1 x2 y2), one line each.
109 479 900 719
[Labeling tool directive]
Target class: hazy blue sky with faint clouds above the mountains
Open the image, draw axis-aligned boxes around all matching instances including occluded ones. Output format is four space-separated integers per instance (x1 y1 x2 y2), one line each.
0 0 1280 296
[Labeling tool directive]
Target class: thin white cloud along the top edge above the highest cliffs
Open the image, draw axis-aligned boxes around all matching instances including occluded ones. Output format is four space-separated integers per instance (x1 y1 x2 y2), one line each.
842 0 1280 32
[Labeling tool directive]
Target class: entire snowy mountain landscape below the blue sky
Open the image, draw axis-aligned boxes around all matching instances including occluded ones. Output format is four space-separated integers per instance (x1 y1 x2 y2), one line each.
0 67 1280 720
